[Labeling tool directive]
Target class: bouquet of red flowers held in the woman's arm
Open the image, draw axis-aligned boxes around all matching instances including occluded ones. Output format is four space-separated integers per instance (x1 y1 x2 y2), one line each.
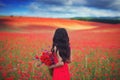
35 51 55 66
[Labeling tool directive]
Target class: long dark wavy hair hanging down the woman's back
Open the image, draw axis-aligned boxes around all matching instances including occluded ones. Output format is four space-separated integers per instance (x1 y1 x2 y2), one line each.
51 28 71 62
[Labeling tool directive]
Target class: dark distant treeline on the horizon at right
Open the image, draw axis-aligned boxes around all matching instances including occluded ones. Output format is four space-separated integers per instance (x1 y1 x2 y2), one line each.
71 17 120 24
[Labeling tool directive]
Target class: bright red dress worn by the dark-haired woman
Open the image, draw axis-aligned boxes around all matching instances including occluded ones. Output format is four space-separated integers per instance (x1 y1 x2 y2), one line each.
52 53 70 80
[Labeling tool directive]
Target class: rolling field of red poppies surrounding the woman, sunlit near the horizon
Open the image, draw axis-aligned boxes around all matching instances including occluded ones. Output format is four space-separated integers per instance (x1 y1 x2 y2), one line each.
0 18 120 80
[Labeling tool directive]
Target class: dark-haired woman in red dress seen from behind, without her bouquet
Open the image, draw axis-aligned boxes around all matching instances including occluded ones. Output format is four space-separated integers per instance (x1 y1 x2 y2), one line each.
49 28 71 80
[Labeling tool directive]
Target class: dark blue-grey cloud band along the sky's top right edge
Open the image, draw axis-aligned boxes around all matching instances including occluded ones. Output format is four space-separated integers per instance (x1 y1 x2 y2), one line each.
36 0 120 10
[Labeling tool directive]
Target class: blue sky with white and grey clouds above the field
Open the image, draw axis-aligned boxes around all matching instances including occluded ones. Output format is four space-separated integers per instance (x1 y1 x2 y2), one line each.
0 0 120 18
